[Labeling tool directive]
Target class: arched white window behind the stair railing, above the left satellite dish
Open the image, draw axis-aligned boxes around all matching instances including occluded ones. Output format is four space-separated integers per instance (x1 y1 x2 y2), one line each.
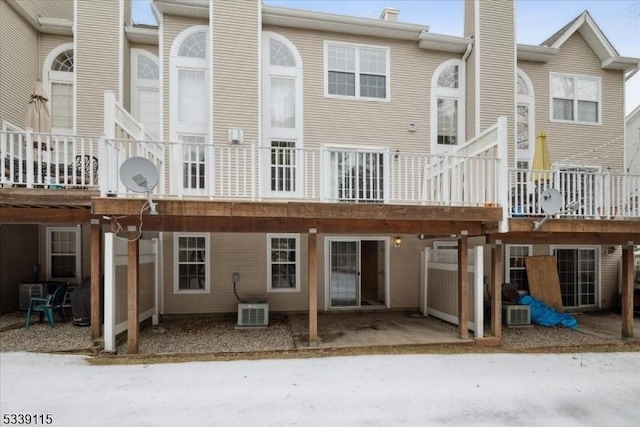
131 49 160 141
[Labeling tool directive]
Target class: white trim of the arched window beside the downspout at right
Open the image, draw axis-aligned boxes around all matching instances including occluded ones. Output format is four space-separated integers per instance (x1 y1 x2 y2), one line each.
430 59 466 154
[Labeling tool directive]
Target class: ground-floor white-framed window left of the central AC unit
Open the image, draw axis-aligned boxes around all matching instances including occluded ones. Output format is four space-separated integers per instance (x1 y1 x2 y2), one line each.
173 233 210 293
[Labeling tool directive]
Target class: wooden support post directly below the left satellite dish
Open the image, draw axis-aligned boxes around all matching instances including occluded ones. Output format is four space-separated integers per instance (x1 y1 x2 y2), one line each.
127 226 140 354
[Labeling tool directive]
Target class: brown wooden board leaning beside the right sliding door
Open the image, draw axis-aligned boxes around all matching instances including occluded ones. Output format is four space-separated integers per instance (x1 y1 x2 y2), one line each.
524 255 563 312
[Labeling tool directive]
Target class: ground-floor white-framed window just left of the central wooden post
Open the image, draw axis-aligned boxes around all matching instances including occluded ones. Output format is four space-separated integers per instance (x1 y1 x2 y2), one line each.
267 234 300 292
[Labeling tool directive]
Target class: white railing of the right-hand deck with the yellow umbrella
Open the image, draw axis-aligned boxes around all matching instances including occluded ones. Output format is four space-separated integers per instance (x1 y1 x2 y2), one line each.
509 169 640 219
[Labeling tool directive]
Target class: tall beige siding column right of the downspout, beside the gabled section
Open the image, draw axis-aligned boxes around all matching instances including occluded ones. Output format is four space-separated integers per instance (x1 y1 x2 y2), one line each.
477 1 516 147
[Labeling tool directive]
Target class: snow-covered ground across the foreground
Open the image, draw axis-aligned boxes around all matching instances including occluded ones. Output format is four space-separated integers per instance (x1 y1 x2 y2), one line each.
0 353 640 427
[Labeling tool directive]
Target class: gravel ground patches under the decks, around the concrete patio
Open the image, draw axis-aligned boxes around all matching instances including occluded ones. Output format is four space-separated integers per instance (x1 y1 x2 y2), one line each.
0 312 616 355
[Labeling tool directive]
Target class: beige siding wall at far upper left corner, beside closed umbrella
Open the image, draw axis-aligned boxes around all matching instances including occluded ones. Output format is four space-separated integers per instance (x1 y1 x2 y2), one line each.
0 2 40 128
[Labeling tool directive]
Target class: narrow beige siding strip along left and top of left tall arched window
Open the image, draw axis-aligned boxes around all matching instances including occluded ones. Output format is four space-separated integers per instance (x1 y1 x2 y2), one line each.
160 15 209 141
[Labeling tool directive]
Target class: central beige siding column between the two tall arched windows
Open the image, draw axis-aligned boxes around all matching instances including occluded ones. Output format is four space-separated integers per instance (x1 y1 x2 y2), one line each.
212 0 260 145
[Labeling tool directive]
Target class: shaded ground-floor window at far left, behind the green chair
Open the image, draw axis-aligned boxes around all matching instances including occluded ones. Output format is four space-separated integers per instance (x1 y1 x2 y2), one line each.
47 226 82 283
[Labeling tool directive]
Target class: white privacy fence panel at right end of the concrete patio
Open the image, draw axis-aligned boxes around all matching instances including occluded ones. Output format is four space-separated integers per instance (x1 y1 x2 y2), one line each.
420 246 484 338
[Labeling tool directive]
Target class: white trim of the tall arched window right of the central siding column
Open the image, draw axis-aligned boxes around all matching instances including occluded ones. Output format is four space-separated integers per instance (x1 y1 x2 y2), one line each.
260 31 304 198
